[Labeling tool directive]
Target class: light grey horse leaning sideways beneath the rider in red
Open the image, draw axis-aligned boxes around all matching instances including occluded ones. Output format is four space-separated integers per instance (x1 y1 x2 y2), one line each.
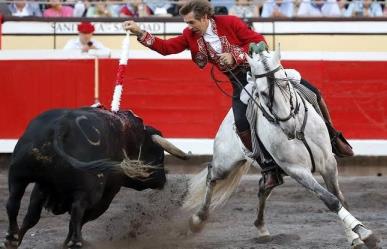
184 44 380 249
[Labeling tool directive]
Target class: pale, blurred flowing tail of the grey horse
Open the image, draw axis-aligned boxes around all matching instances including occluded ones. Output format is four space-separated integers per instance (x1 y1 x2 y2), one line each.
183 160 252 210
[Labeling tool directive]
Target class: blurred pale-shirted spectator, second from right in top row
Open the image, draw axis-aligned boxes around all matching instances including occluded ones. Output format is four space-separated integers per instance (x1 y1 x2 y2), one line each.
297 0 340 17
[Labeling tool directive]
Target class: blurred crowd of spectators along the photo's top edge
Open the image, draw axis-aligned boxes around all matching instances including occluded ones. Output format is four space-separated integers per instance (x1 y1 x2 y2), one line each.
0 0 387 18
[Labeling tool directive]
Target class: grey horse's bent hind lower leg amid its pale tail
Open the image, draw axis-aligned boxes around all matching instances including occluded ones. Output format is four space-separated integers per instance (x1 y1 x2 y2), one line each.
189 176 216 233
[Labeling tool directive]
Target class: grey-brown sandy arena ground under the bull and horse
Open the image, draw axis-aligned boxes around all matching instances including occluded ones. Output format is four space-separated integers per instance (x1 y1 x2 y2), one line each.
0 167 387 249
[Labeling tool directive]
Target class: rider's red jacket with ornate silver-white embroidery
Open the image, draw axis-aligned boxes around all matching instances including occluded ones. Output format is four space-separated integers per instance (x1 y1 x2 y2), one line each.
139 16 266 71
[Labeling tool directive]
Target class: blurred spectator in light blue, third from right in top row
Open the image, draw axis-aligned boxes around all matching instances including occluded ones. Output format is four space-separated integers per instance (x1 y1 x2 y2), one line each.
261 0 294 18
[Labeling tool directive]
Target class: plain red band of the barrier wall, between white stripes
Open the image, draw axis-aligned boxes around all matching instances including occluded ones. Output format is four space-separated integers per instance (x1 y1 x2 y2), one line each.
0 59 387 139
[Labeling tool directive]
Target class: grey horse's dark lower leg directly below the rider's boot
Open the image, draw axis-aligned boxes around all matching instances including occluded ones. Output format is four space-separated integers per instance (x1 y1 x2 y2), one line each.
254 177 273 241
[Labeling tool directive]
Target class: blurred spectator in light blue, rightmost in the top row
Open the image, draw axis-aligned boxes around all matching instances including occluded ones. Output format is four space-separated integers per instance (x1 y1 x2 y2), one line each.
344 0 383 17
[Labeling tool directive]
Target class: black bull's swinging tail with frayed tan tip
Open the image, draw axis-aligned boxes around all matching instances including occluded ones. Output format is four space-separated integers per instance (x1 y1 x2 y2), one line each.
53 124 154 179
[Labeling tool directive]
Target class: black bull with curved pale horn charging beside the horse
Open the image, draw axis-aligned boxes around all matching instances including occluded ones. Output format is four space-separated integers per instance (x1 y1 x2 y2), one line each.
0 108 187 248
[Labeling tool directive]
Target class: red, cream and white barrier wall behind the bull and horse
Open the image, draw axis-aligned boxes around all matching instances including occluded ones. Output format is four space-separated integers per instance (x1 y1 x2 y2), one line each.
0 17 387 155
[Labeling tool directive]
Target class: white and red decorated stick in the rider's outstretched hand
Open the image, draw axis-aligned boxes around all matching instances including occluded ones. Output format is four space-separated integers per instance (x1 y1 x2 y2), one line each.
111 32 130 112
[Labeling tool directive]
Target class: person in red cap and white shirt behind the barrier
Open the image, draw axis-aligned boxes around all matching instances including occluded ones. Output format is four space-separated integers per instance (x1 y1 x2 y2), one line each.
64 22 110 56
